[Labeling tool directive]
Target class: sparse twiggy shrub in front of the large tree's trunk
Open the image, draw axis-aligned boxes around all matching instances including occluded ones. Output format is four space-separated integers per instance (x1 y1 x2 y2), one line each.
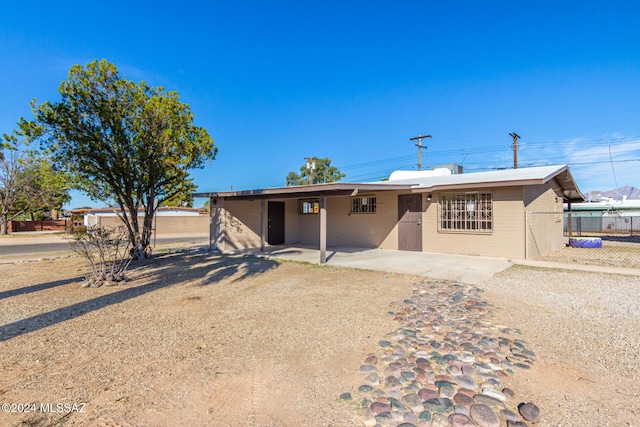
69 226 132 287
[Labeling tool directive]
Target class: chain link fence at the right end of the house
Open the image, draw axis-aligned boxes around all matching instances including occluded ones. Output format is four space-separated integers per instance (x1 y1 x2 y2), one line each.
527 212 640 268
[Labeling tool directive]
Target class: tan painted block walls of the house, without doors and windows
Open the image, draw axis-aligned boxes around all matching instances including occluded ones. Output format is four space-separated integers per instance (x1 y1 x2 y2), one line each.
212 182 564 259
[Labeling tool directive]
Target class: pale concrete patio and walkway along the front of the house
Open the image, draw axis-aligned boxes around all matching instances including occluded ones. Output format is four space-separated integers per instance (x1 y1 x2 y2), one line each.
258 246 640 284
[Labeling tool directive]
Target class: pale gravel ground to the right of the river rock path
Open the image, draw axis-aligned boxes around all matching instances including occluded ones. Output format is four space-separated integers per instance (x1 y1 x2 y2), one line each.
479 267 640 426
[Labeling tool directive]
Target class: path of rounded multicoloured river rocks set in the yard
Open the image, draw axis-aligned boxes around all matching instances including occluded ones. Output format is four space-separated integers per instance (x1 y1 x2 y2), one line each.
340 281 541 427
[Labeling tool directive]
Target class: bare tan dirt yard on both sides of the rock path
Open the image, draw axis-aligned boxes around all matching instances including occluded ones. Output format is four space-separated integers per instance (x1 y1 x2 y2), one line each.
0 252 640 427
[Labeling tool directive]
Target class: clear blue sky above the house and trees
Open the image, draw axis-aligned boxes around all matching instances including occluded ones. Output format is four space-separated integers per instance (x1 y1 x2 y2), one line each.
0 0 640 207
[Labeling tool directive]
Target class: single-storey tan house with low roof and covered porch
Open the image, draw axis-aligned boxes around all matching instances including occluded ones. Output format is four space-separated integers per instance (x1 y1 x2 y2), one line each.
194 165 584 262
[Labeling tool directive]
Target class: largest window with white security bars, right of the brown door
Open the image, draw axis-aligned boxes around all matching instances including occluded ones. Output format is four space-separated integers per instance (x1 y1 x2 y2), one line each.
439 193 493 233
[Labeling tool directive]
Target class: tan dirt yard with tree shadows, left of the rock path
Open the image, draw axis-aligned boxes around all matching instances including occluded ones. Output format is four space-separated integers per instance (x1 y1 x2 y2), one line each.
0 252 414 426
